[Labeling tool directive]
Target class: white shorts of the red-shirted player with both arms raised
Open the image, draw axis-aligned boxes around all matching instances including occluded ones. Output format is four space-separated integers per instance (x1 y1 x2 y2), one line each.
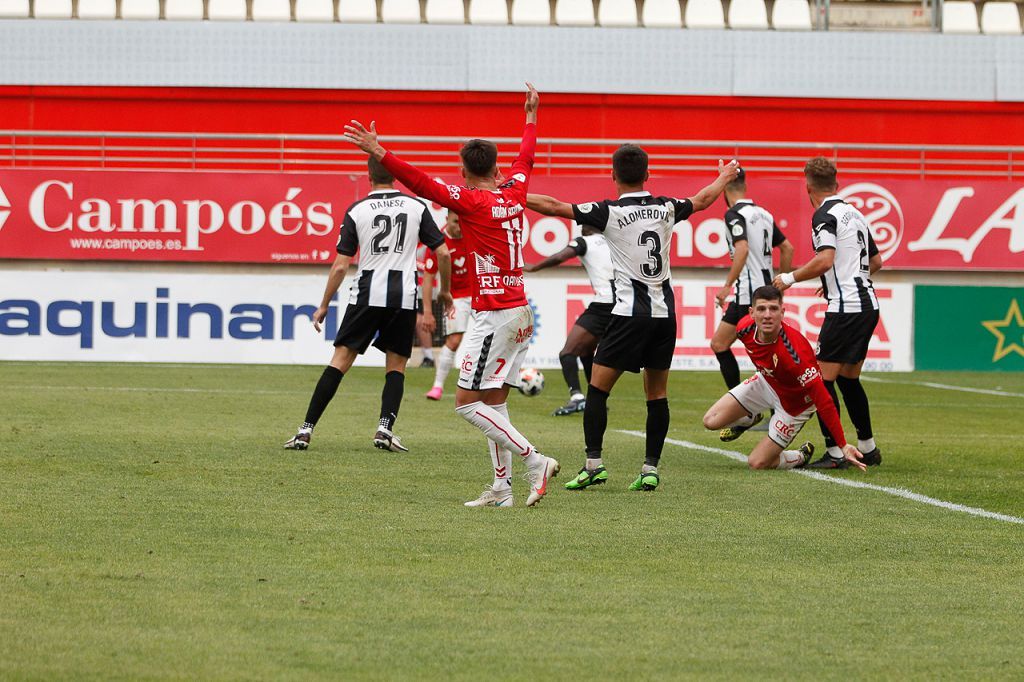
459 305 534 391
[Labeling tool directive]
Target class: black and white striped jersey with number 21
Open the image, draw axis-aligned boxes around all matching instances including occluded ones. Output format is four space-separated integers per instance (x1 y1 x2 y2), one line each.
338 189 444 310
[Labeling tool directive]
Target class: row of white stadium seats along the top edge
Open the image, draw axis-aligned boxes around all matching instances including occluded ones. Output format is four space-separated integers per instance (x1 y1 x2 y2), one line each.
0 0 1021 35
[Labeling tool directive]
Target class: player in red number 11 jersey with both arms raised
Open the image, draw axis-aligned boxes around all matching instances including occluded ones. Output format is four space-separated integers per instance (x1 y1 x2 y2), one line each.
344 83 559 507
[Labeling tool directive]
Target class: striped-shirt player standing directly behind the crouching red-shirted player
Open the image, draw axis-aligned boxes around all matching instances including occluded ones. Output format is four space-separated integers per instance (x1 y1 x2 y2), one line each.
711 168 793 388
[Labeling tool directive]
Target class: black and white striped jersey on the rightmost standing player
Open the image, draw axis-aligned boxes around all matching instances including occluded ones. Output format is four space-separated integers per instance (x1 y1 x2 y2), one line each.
811 196 879 312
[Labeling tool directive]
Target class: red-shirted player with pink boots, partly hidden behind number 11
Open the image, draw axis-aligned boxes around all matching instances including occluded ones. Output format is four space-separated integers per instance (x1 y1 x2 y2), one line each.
420 211 473 400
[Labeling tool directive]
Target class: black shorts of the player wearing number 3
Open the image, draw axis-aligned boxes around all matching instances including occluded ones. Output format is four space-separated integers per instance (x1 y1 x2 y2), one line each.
594 315 676 372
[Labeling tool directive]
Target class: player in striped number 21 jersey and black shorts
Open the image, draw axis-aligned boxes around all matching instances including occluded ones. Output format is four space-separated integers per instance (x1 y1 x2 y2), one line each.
285 159 452 453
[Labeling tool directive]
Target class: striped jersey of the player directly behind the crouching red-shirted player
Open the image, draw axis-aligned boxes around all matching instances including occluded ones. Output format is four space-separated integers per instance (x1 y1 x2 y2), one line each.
725 199 785 306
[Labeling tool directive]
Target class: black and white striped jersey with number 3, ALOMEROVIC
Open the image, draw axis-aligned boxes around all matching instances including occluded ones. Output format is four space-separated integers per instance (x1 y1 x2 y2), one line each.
572 191 693 317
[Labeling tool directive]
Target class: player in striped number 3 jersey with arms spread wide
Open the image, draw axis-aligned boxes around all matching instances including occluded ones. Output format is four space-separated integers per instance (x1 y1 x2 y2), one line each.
527 144 738 491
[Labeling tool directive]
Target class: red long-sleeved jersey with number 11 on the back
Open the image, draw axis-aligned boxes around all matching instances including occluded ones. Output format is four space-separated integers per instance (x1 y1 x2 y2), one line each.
381 123 537 310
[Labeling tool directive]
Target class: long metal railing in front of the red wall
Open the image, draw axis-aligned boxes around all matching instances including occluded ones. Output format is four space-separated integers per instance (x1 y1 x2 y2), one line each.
0 130 1024 180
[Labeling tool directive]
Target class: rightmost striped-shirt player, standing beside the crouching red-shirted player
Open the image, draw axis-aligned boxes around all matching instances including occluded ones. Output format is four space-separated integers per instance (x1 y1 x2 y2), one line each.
774 157 882 469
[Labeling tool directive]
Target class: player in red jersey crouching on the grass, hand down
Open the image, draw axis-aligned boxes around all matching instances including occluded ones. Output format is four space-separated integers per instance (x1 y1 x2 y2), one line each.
703 285 865 470
